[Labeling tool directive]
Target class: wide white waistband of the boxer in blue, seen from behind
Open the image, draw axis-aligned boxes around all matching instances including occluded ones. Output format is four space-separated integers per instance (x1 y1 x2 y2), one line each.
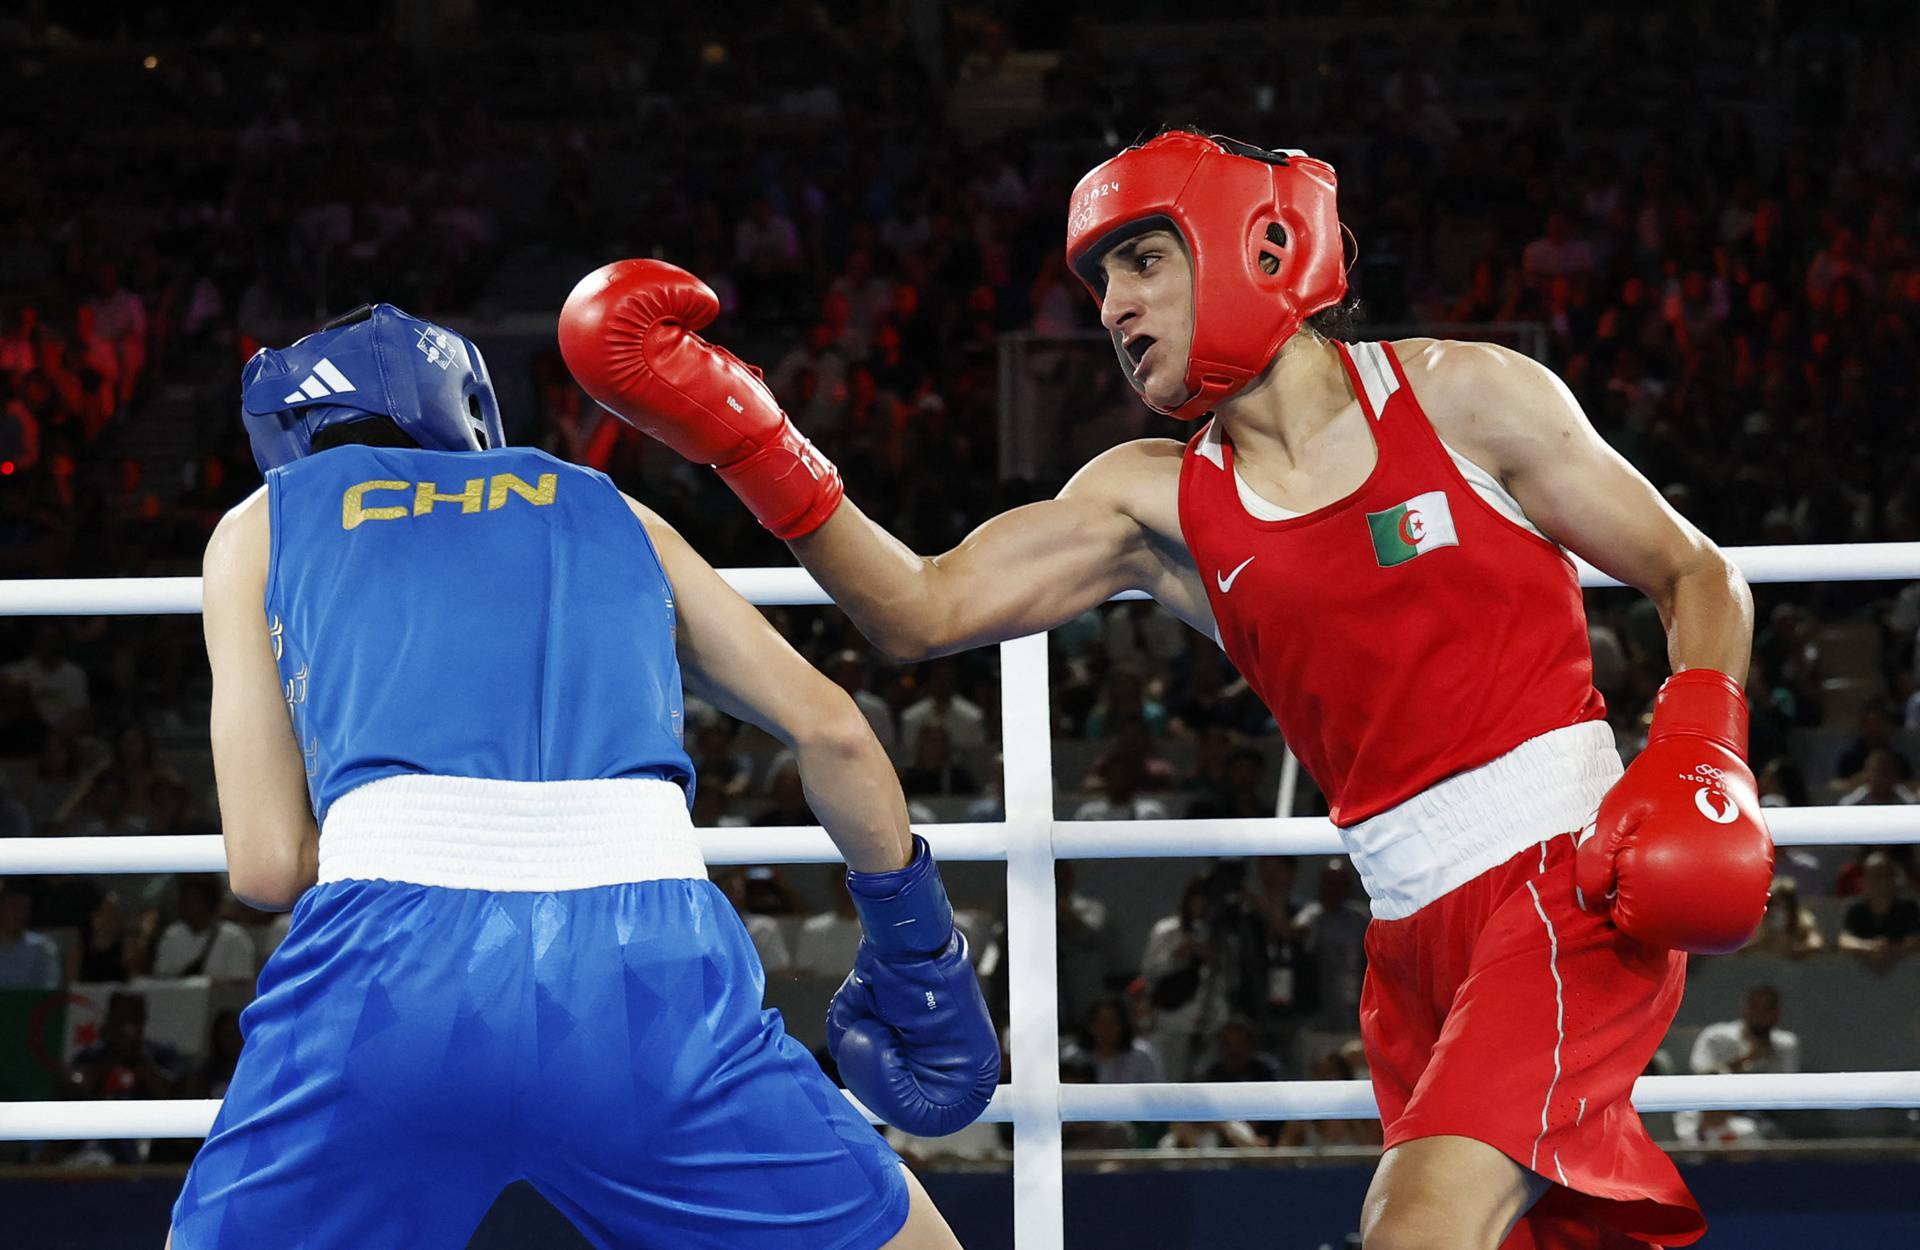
321 774 707 891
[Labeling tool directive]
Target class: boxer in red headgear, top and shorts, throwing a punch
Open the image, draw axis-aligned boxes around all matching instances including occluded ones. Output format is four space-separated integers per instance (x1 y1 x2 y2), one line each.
561 131 1772 1250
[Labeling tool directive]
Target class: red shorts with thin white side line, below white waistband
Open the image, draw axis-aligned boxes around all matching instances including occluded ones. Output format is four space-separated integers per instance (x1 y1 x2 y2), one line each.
1359 835 1707 1250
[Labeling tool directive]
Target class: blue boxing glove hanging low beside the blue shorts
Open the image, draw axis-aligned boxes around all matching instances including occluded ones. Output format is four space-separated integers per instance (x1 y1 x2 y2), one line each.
828 835 1000 1137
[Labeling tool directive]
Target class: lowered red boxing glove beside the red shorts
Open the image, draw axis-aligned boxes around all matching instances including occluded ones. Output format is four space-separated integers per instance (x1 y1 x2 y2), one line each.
1574 668 1774 954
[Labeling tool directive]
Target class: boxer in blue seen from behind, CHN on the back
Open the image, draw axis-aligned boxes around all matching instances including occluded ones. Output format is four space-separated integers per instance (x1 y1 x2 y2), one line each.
169 305 1000 1250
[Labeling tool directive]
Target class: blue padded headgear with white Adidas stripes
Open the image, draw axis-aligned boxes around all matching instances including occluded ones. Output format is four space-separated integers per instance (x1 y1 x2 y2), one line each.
240 303 507 472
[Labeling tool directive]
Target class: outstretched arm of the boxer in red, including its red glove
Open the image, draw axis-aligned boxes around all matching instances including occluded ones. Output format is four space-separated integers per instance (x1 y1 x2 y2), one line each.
559 259 1213 659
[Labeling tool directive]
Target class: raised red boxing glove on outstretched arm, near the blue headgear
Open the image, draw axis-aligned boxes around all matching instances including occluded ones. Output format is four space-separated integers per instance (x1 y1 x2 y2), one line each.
561 261 847 538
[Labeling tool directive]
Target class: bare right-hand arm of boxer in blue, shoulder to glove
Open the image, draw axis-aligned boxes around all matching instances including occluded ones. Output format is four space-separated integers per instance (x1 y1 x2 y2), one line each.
626 499 910 872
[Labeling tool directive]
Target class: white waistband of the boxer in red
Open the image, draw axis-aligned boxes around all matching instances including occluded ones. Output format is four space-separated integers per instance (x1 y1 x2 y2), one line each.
1340 720 1620 920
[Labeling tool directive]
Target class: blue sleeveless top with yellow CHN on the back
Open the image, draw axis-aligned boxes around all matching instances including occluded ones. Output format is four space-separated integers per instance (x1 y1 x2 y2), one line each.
267 445 693 822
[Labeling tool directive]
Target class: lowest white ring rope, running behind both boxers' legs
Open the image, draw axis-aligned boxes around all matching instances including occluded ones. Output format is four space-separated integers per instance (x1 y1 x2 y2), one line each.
0 1071 1920 1141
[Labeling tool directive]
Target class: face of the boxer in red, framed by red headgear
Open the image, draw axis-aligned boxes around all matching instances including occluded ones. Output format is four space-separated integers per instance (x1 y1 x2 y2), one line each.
1100 230 1194 409
